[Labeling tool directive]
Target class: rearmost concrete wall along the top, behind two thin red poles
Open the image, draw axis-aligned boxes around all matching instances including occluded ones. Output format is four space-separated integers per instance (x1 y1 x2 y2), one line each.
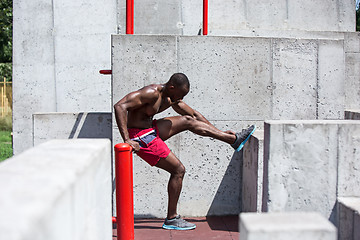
118 0 355 35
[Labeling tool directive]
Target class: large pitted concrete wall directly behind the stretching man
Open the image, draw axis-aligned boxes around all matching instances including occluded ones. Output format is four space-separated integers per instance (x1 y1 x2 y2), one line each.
112 35 344 216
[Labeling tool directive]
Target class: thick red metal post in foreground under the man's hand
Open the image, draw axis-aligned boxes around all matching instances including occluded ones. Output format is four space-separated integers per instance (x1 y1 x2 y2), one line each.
114 143 134 240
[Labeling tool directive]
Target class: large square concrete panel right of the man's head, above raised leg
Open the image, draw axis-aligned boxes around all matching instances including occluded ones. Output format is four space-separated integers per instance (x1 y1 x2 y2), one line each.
178 37 271 121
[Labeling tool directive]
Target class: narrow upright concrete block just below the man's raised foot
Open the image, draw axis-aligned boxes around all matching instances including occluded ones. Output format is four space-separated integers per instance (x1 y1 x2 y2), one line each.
241 130 264 212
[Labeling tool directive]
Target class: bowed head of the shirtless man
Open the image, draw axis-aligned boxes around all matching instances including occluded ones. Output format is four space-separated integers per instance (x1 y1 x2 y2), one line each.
166 73 190 102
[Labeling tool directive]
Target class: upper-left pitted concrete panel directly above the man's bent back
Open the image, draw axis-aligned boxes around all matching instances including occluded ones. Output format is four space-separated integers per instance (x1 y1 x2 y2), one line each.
112 35 177 126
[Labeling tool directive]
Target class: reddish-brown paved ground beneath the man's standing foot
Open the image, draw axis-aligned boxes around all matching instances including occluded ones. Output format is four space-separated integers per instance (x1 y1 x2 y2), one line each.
113 216 239 240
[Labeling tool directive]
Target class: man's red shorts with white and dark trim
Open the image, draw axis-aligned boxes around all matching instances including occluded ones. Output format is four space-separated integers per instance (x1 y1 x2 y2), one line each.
128 120 170 166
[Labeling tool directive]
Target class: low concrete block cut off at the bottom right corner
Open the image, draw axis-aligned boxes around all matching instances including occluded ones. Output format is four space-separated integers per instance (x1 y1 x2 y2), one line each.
338 197 360 240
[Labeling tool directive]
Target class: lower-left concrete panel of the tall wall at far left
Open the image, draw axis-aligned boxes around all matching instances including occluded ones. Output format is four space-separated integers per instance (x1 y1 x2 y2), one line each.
13 64 56 154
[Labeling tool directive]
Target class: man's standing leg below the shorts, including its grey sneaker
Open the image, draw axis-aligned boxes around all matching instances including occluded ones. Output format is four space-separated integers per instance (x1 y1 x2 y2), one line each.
155 152 196 230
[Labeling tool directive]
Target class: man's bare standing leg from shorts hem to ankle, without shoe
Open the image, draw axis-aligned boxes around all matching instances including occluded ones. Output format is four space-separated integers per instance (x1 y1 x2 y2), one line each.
156 152 185 219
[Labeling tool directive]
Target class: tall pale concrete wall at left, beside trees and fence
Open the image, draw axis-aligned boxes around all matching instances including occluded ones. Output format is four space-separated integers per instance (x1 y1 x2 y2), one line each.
13 0 117 154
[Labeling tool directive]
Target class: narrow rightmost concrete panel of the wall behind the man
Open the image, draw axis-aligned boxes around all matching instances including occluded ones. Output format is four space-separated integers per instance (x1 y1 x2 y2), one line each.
317 40 345 119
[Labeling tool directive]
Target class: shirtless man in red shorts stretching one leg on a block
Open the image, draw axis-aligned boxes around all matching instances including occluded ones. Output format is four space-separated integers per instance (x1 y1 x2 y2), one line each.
114 73 255 230
